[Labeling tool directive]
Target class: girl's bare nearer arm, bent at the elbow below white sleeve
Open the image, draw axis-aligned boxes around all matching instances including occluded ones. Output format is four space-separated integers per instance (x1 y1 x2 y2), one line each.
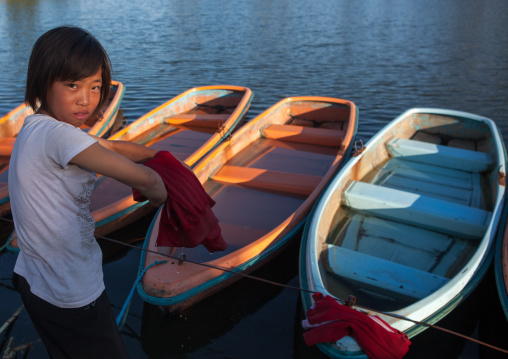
70 141 167 207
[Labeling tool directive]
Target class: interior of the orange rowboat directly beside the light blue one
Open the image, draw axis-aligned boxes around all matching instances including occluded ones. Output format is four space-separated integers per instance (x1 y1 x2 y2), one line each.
178 101 350 261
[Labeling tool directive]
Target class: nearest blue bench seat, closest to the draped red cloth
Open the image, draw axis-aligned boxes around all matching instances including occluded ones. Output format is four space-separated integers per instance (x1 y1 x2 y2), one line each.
327 248 449 299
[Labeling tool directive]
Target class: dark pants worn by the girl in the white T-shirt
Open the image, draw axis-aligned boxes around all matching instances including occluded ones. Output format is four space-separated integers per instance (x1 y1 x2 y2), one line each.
13 274 128 359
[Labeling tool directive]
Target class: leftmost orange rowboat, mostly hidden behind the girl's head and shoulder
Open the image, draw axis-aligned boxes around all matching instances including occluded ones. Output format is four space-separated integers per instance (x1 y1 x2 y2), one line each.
0 81 125 216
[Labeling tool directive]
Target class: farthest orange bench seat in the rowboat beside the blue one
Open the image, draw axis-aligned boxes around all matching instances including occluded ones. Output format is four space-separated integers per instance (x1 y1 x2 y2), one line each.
262 125 345 148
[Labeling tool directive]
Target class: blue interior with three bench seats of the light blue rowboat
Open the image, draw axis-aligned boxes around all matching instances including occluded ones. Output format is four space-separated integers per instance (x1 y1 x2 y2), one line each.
321 114 498 310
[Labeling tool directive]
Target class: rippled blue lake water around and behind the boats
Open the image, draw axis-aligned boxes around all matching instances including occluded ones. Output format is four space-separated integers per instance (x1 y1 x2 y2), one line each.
0 0 508 358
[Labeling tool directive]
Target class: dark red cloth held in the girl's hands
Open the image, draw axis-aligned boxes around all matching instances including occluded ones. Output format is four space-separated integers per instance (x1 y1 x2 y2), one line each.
132 151 228 252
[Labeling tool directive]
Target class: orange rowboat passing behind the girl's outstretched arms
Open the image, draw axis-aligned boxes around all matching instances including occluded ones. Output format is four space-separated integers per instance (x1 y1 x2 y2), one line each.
6 86 252 252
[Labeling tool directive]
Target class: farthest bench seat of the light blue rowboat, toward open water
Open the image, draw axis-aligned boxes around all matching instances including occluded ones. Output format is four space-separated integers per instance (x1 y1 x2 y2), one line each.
386 138 493 172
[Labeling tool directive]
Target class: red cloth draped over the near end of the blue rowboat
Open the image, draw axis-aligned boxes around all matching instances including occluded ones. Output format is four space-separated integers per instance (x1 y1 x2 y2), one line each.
303 293 411 359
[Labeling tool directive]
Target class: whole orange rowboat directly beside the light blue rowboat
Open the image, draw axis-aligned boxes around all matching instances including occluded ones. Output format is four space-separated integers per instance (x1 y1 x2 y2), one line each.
137 97 358 312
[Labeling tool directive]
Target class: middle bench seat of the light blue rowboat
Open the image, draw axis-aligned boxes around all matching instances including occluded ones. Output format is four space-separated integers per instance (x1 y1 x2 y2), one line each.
344 181 491 239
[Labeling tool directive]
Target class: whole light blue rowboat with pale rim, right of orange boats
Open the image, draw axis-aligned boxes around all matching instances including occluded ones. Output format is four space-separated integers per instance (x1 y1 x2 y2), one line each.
300 109 506 358
